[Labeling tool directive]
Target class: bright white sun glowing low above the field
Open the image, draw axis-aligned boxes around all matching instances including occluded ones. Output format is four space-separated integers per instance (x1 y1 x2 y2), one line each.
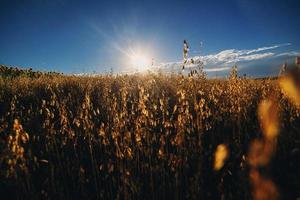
129 51 152 72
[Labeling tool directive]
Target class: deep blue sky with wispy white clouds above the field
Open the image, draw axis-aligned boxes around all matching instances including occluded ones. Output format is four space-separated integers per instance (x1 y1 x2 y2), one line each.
0 0 300 76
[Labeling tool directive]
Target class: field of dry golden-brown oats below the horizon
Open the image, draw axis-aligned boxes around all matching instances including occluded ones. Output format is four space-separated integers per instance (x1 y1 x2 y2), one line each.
0 65 300 199
